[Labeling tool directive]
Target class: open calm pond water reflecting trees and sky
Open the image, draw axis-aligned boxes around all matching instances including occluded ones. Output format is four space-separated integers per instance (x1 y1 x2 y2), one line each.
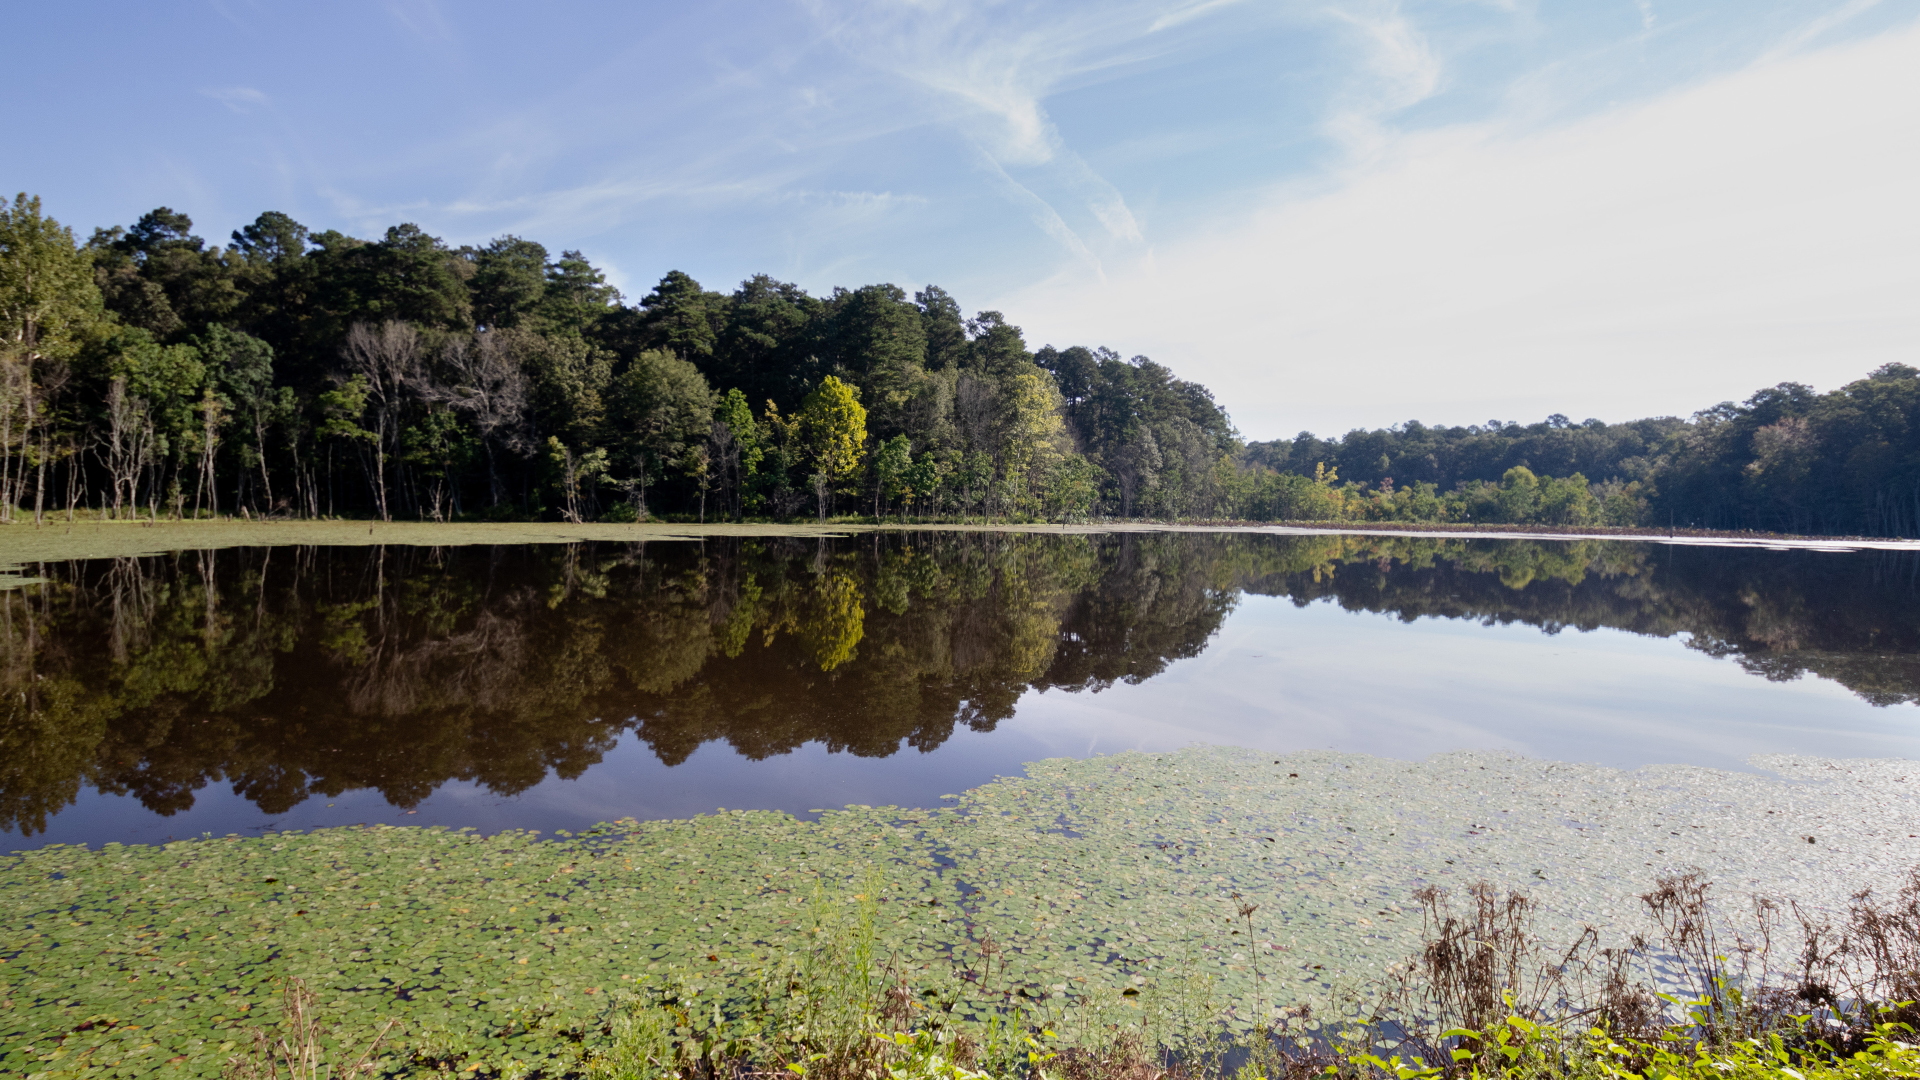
0 532 1920 849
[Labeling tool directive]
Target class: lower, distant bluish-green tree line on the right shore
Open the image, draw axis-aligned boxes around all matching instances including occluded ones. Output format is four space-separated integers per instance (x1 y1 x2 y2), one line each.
1240 372 1920 536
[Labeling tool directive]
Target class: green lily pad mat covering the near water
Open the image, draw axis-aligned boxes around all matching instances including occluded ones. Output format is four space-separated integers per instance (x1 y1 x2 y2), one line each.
0 748 1920 1076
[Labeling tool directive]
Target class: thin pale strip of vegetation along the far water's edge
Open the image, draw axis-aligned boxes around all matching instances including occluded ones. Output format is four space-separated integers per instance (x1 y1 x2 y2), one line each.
0 519 1920 567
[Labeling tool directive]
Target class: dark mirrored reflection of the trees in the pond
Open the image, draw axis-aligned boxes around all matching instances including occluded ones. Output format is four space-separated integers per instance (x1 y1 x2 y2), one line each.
0 532 1920 834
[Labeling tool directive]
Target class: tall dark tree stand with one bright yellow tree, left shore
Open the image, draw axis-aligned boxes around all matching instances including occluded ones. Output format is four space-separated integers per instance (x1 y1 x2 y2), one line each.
0 194 1238 521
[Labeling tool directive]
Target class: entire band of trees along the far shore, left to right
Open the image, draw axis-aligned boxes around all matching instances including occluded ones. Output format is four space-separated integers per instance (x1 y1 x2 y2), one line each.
0 194 1920 536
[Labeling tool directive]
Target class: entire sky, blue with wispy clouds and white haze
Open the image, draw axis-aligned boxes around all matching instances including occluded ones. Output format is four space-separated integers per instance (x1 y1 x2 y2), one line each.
0 0 1920 438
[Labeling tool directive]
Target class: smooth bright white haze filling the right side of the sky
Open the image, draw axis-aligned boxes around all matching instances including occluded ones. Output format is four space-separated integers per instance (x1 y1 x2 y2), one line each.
1002 15 1920 436
